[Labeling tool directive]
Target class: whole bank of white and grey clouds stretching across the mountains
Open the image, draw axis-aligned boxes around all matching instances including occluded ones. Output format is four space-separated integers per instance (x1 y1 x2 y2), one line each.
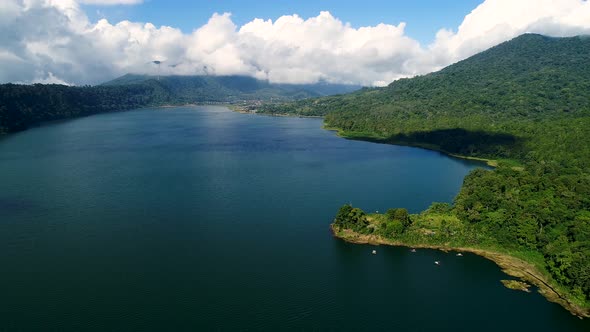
0 0 590 85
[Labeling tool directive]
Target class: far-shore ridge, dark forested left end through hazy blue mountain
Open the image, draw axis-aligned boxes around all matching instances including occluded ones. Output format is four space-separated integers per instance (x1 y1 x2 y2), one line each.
0 75 357 134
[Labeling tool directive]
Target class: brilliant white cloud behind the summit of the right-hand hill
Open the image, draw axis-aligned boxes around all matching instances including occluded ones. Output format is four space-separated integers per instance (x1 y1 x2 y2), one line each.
429 0 590 68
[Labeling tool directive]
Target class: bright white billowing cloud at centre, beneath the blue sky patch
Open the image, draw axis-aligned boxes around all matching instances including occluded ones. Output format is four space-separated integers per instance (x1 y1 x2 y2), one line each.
238 12 422 85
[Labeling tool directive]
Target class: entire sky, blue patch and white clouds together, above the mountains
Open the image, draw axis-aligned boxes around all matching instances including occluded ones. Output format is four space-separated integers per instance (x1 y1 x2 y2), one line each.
0 0 590 86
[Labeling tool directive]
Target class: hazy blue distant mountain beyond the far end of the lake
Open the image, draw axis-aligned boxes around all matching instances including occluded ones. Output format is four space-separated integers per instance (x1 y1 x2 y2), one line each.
102 74 361 103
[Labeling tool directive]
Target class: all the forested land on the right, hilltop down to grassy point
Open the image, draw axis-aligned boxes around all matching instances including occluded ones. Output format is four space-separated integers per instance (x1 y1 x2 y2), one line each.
260 34 590 316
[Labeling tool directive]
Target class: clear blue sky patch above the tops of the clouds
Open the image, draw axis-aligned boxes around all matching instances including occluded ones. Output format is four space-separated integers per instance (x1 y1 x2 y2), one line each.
83 0 482 44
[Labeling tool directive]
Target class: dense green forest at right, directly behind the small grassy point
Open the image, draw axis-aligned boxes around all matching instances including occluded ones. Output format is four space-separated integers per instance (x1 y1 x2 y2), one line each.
455 162 590 298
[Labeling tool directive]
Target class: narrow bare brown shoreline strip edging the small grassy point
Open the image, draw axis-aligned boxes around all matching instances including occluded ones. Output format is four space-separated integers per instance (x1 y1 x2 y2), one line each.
330 224 590 319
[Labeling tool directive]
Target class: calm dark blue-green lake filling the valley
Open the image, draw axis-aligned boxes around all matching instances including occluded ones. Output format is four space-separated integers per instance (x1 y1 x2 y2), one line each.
0 107 590 331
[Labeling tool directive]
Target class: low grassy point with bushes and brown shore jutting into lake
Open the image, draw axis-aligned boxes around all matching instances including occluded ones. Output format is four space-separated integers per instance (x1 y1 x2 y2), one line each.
331 208 590 318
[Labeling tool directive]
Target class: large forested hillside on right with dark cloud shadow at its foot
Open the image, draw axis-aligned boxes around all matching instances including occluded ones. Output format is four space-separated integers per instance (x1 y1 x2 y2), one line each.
260 34 590 159
